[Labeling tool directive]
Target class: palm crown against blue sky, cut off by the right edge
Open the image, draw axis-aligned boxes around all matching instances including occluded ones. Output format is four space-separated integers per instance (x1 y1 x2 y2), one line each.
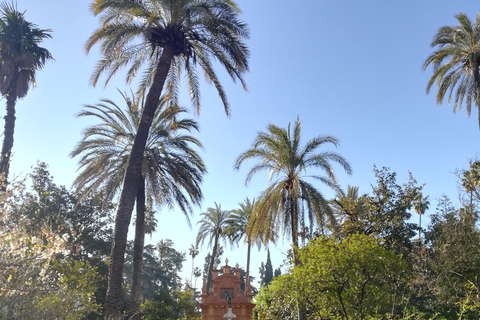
423 13 480 128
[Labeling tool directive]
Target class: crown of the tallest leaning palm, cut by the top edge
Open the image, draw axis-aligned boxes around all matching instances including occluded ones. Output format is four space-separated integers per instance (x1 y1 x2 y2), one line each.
86 0 249 114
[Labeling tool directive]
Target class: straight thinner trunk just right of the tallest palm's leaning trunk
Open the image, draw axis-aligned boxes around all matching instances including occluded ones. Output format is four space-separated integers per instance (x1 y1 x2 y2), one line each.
130 176 145 320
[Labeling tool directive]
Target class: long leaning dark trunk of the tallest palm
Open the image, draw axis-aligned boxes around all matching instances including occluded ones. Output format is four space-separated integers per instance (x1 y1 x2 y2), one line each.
105 46 174 320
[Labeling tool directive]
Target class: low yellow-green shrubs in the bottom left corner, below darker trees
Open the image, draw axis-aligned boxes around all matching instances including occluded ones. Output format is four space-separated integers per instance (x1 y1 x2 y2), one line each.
0 251 99 320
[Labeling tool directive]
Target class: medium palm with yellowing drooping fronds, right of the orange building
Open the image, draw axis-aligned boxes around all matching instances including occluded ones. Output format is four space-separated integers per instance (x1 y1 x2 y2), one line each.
235 118 352 265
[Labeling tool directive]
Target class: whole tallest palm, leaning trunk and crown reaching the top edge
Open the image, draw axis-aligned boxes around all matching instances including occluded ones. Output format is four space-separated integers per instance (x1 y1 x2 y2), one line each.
86 0 249 319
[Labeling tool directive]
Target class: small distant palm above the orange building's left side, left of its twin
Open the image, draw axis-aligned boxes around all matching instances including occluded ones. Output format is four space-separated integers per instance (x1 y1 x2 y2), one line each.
196 202 230 292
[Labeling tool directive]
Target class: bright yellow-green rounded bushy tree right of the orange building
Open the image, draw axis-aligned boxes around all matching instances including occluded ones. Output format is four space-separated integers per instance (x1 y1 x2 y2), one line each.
257 234 406 319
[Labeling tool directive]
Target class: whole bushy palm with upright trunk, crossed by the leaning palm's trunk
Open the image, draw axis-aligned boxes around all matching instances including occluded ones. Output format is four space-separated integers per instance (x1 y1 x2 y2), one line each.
71 94 206 318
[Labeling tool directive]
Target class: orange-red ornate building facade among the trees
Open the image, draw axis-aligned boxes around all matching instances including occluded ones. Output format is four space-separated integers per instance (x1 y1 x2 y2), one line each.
200 265 255 320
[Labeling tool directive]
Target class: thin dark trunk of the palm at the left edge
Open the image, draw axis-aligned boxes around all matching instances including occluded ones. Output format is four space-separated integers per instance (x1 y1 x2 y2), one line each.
0 86 17 191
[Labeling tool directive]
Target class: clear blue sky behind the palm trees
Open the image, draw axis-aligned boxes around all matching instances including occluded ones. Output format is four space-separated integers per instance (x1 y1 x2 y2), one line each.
8 0 480 288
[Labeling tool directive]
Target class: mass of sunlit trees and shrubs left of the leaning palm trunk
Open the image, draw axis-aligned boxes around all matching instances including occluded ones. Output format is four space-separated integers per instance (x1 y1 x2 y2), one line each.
0 163 111 319
